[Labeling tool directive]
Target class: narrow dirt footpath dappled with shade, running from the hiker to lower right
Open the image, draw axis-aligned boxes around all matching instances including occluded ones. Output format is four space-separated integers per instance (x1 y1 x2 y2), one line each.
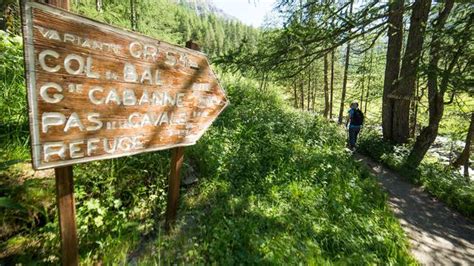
355 154 474 265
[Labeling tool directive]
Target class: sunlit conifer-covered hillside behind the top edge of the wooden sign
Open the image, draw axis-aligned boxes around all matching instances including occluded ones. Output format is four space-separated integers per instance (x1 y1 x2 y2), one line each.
72 0 259 56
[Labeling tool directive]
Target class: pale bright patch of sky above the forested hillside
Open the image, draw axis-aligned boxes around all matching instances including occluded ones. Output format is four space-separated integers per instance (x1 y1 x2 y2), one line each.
213 0 275 27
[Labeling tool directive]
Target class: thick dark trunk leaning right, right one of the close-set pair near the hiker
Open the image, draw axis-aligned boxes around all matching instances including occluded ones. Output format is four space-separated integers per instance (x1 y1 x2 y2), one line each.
390 0 431 143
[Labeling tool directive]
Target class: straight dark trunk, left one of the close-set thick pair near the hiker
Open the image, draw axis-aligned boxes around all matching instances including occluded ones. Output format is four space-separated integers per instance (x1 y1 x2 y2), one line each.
382 0 404 141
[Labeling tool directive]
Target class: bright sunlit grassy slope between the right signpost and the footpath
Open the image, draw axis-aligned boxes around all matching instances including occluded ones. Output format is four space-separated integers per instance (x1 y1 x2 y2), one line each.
129 76 414 264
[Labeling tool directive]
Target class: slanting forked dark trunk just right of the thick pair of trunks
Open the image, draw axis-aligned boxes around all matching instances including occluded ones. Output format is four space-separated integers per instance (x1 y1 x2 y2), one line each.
406 0 462 168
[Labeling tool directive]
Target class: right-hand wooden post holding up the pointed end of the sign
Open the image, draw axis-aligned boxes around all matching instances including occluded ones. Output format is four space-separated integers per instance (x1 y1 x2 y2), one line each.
165 40 200 230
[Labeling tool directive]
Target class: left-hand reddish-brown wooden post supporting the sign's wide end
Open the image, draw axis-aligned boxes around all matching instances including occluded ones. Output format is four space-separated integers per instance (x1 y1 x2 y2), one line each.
47 0 79 266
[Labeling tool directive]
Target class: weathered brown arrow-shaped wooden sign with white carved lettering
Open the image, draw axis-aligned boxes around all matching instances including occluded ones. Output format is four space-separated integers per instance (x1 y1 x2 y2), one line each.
22 1 228 169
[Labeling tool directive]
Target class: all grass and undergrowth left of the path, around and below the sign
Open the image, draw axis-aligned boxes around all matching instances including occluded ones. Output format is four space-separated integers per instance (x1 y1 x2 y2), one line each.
0 32 415 264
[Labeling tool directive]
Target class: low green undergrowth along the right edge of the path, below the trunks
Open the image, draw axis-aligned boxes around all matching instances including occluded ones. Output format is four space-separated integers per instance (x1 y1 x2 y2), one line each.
358 131 474 217
